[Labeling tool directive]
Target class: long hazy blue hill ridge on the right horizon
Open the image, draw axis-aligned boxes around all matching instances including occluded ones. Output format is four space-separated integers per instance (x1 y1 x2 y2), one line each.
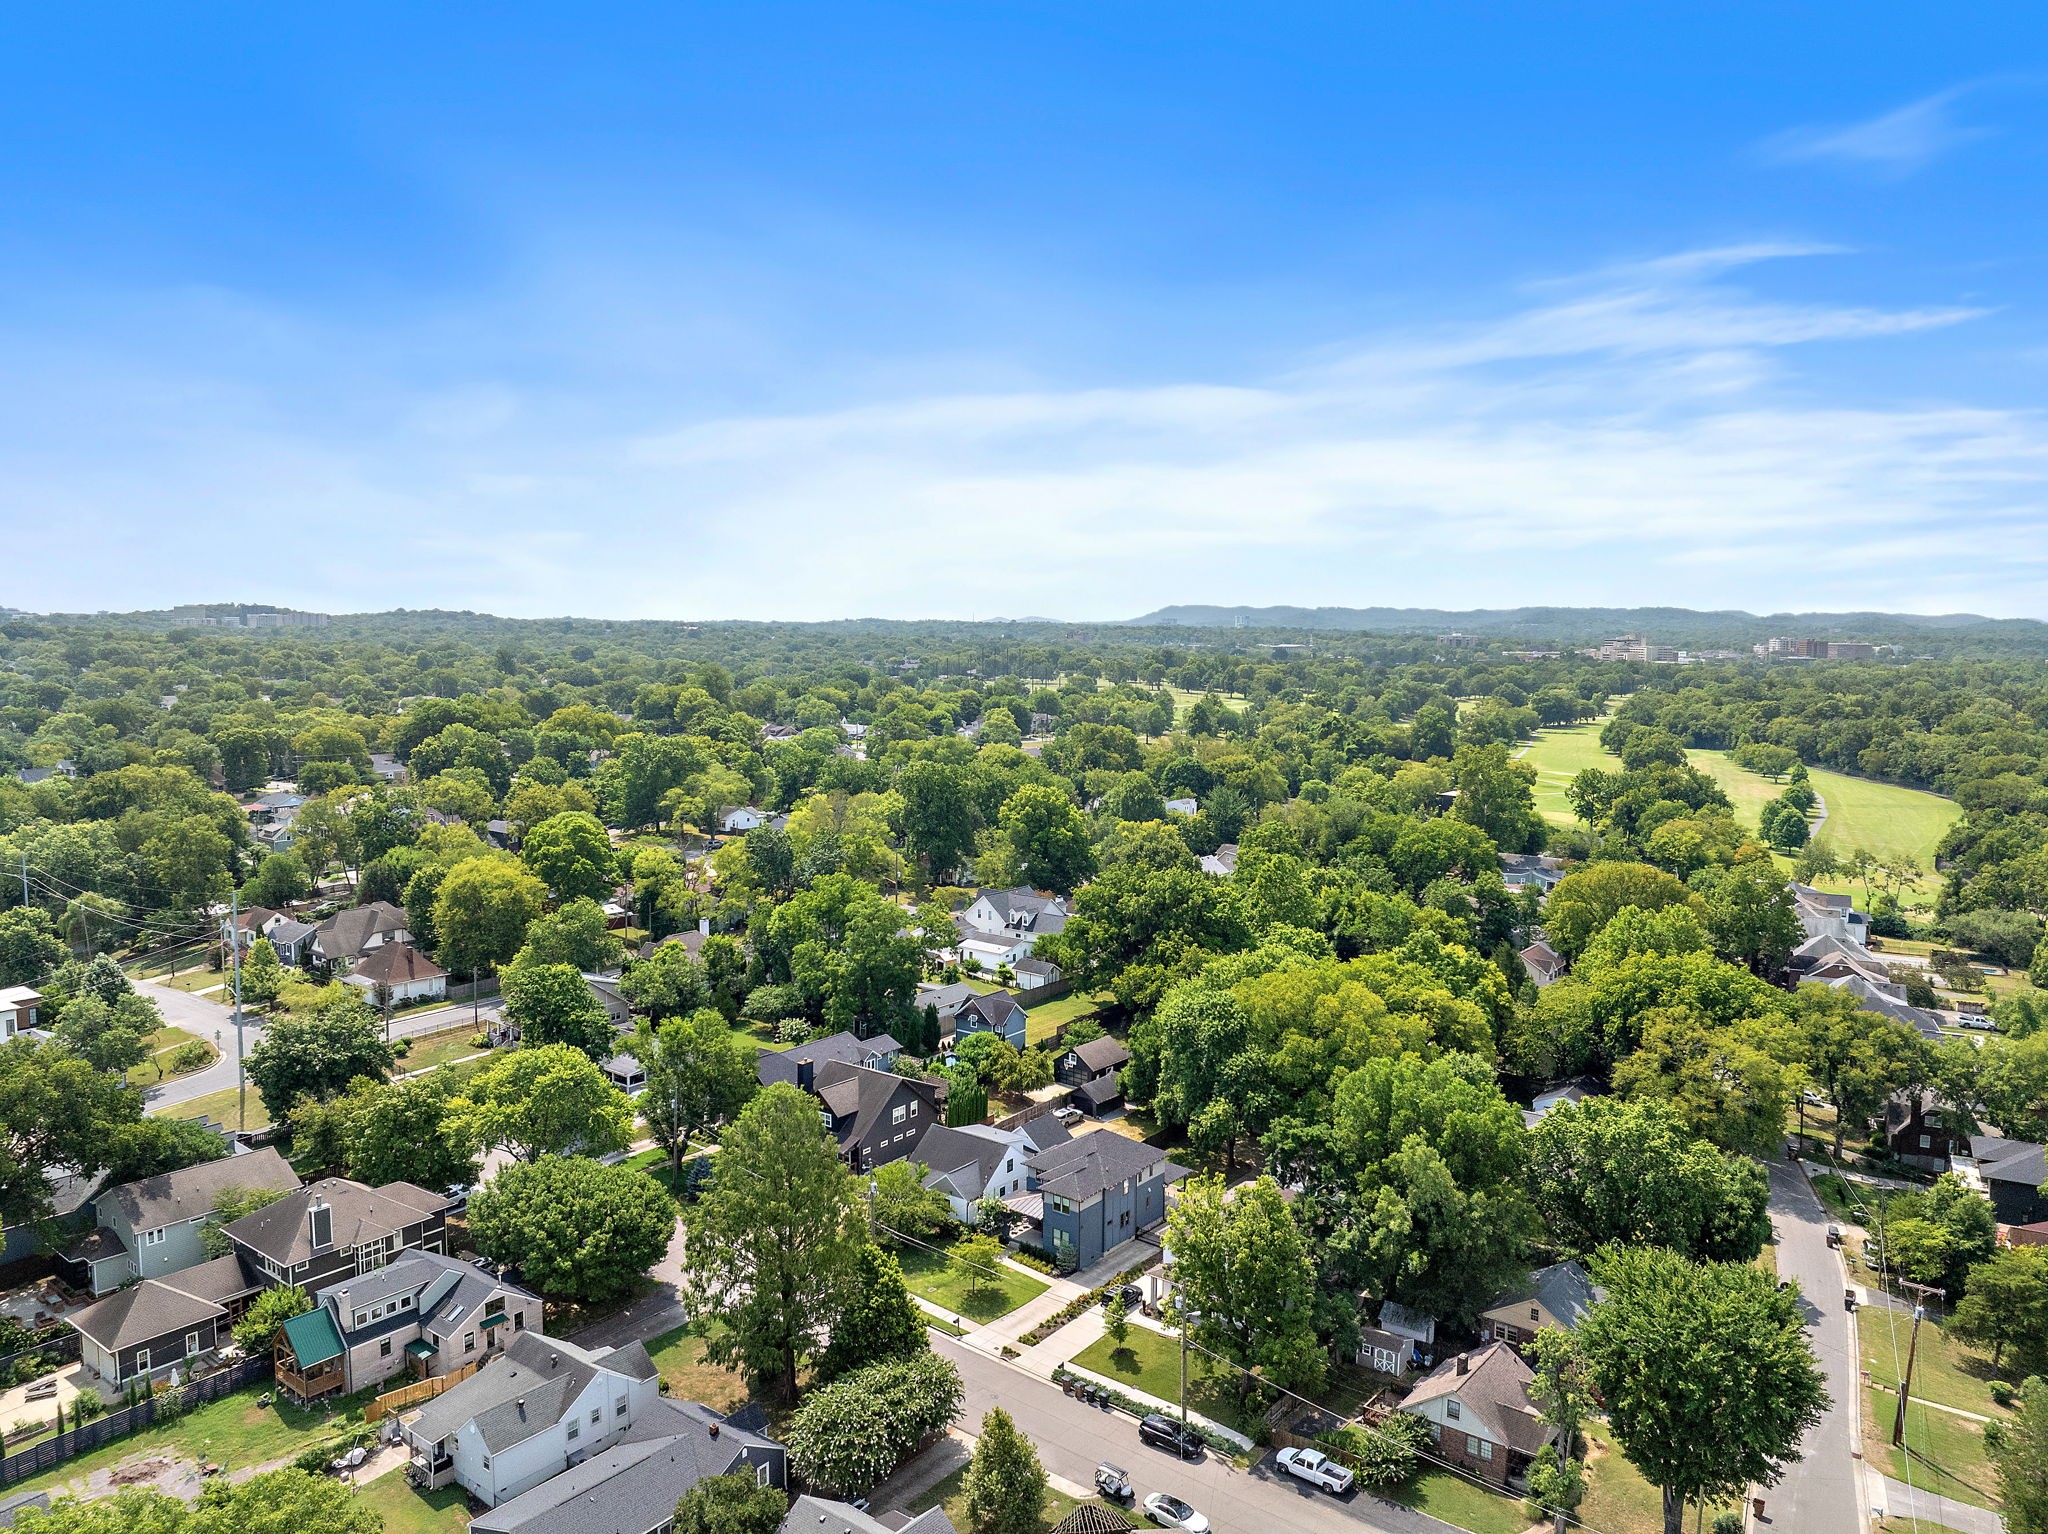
1128 604 2048 643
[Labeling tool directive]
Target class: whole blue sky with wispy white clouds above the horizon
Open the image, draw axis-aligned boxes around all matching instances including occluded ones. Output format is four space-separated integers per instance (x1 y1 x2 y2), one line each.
0 0 2048 619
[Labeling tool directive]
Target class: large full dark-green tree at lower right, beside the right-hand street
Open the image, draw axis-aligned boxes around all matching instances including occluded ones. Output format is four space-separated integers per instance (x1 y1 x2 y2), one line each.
1579 1247 1829 1534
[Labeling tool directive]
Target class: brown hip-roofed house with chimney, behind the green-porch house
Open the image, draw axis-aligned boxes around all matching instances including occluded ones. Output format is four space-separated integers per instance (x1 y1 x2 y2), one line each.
223 1178 449 1292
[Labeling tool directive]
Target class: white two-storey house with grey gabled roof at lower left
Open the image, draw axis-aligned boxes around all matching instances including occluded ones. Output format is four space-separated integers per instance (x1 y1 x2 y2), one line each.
406 1331 662 1507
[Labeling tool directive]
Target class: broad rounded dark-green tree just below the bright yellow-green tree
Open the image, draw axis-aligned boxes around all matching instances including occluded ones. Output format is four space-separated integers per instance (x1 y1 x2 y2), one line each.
469 1155 676 1303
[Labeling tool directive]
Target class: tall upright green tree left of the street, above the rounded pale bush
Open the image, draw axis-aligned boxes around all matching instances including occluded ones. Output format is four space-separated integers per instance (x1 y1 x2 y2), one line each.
684 1083 856 1415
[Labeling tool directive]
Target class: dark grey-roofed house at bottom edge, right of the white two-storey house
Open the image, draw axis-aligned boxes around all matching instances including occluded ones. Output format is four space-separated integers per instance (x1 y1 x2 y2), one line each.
469 1399 788 1534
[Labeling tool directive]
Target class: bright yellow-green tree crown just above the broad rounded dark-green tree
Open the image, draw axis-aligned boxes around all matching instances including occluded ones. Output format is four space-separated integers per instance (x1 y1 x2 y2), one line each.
446 1045 633 1161
